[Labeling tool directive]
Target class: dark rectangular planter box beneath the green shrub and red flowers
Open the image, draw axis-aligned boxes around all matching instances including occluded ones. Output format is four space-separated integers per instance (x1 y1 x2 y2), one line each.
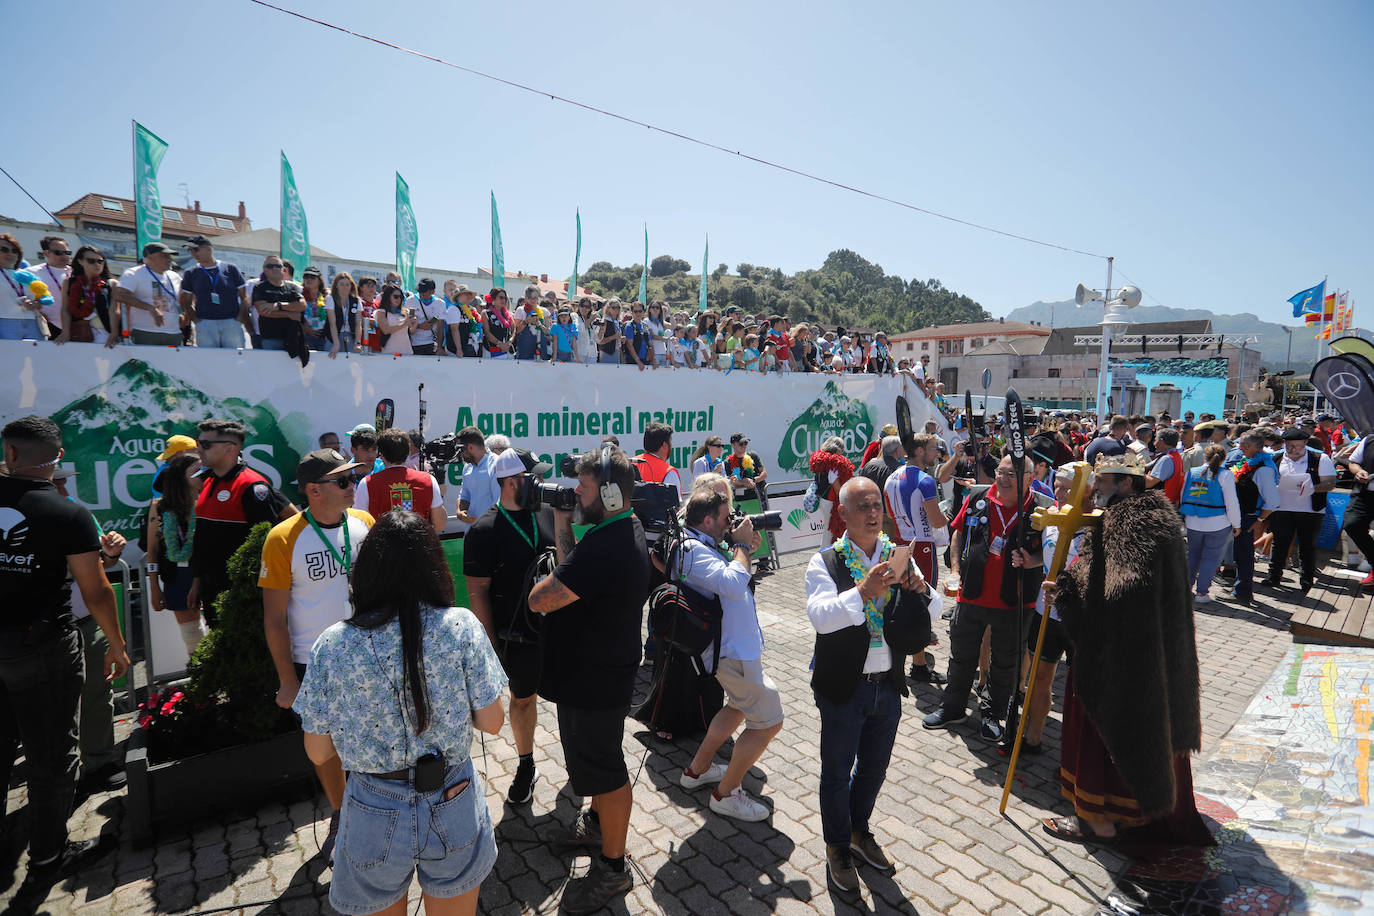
125 728 315 846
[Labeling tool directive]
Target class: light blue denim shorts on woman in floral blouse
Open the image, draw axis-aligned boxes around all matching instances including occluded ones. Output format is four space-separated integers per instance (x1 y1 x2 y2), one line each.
330 758 496 916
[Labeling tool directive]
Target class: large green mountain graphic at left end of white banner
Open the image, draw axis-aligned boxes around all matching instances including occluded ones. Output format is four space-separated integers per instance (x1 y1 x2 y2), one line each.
52 360 300 540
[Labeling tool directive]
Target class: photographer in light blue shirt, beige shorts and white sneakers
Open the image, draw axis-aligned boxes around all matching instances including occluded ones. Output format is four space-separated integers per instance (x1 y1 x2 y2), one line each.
675 490 783 821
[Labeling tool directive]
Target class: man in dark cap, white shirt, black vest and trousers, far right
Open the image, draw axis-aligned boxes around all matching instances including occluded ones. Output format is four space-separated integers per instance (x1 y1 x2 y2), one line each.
1264 427 1336 595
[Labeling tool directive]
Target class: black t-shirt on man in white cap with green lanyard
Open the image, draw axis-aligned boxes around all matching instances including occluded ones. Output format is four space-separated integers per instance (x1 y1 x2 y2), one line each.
463 505 562 633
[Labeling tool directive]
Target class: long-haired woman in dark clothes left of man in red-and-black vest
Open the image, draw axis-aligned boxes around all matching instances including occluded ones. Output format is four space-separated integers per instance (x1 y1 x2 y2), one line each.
146 450 202 658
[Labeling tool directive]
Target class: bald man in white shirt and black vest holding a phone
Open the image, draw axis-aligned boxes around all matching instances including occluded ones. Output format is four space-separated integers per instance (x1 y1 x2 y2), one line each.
807 477 926 891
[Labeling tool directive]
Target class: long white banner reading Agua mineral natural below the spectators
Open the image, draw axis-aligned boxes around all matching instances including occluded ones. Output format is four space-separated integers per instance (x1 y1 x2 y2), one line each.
0 341 944 555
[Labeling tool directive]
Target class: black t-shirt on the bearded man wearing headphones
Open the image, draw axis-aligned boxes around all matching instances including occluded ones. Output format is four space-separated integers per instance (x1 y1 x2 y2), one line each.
539 515 649 709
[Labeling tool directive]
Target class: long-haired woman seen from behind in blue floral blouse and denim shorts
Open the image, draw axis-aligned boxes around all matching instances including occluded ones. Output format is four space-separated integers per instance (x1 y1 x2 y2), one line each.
294 509 506 915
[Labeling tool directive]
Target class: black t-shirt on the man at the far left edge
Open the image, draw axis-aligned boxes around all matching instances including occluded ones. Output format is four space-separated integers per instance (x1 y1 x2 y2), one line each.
0 477 100 628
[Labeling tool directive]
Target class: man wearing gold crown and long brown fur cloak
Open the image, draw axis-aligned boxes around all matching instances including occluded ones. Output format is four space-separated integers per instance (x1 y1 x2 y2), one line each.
1044 452 1212 854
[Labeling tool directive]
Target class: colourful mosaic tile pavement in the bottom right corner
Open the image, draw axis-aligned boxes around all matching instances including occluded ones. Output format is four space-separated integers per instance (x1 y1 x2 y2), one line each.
1092 645 1374 916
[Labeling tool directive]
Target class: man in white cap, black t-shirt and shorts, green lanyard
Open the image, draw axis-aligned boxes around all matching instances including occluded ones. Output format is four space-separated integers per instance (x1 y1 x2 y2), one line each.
463 449 554 805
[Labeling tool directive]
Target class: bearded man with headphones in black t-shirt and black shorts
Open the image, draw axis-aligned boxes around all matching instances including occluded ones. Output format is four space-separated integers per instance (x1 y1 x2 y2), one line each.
529 446 649 913
